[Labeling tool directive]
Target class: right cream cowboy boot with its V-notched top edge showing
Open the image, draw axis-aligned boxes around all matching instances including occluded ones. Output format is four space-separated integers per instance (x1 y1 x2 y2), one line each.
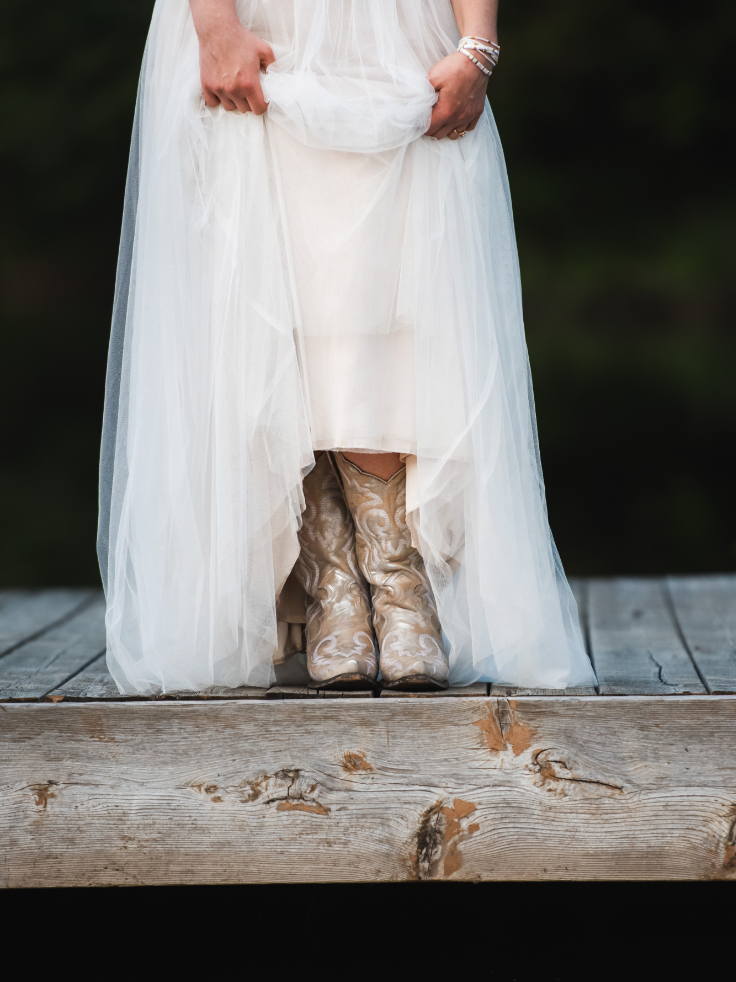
334 453 449 691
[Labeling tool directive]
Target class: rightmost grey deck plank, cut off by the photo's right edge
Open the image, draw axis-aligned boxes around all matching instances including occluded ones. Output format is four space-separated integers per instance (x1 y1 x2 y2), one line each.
667 575 736 693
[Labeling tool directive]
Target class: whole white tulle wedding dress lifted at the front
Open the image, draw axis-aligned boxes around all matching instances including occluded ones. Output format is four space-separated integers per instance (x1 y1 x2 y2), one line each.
100 0 593 693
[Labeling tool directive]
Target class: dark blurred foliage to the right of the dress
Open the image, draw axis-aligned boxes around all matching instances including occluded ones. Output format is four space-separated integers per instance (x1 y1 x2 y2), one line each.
490 0 736 574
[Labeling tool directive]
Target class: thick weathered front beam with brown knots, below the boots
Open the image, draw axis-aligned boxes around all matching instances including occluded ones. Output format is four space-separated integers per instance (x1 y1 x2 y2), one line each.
0 696 736 887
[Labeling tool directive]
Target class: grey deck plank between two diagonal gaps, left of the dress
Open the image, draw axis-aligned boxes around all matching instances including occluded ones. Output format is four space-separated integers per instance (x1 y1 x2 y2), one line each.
0 595 105 702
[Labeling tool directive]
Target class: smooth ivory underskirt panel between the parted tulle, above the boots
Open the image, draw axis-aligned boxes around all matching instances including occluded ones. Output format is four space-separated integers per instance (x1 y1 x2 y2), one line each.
268 126 417 454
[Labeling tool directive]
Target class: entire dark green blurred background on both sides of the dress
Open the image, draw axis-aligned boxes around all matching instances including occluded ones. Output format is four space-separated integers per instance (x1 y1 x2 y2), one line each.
0 0 736 585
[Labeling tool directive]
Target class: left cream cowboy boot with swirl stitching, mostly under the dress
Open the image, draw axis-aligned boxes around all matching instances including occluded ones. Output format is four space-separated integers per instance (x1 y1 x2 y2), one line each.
294 453 378 689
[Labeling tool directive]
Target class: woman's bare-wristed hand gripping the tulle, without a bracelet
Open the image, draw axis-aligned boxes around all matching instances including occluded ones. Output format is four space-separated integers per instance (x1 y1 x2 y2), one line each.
189 0 276 116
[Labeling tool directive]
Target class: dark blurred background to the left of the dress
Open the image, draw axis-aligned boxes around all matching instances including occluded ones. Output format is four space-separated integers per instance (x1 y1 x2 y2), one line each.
0 0 153 585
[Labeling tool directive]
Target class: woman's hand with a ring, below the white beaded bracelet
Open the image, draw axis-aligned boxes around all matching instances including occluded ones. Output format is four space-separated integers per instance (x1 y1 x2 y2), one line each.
425 51 488 140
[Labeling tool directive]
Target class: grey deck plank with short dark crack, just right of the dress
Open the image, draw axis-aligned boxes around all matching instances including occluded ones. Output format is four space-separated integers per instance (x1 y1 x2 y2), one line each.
588 579 707 695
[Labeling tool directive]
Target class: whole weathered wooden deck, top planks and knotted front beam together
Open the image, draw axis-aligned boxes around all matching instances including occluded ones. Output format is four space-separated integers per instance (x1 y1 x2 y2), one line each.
0 575 736 887
